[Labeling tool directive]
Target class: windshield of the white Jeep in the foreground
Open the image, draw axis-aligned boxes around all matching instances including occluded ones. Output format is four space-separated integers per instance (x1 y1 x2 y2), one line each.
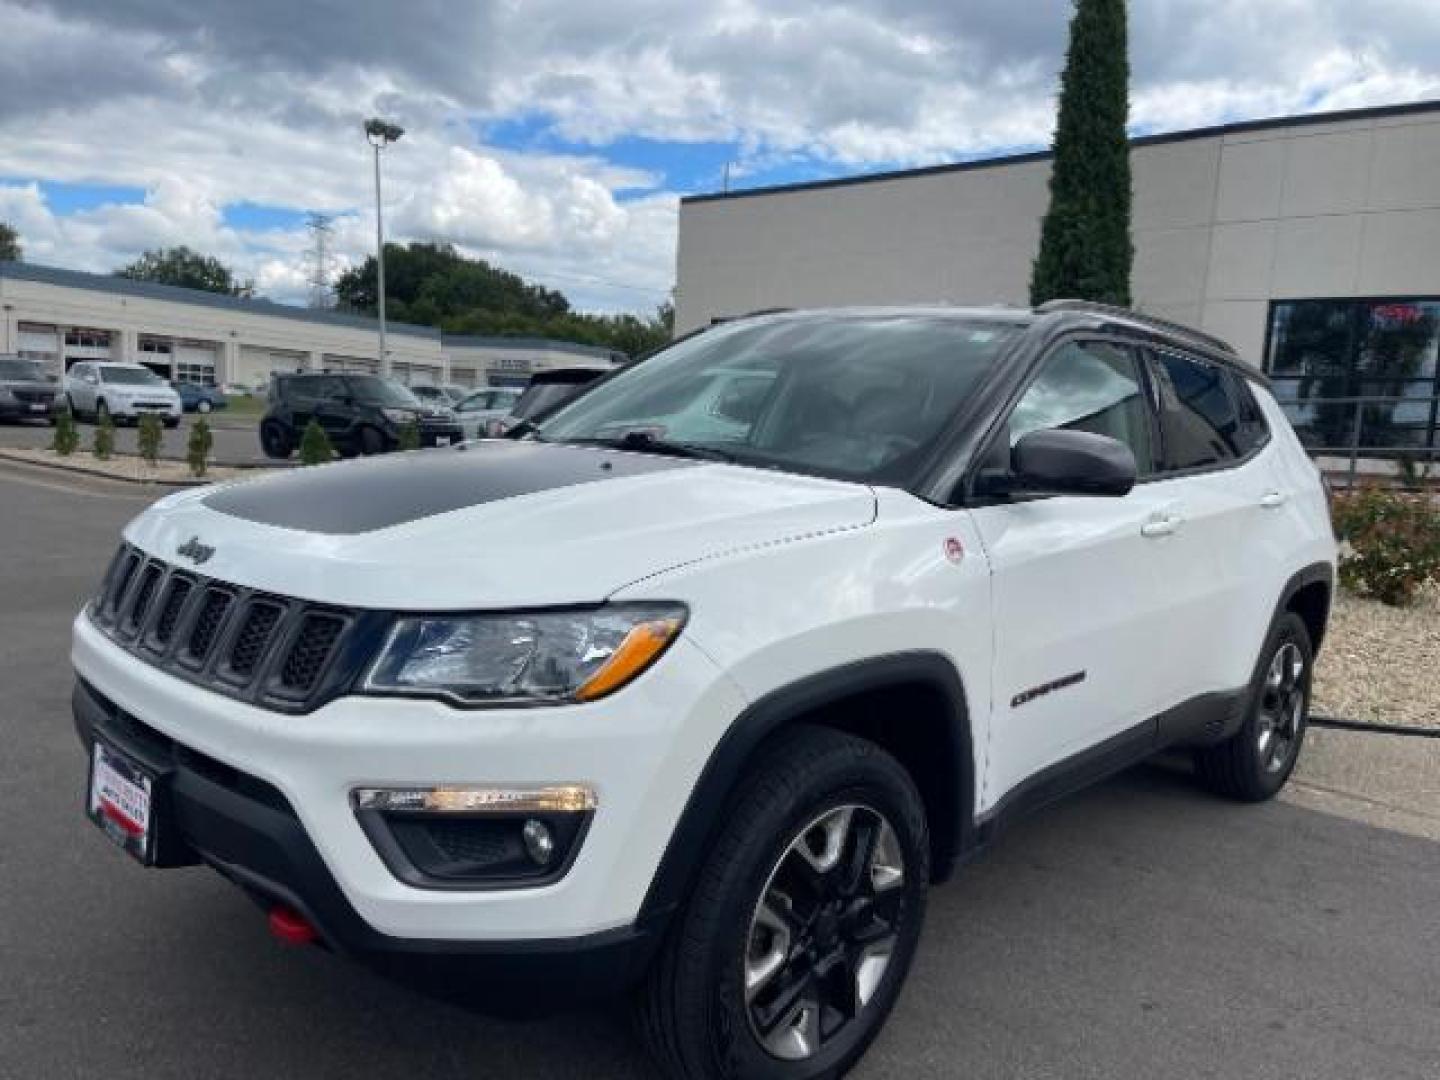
539 314 1022 482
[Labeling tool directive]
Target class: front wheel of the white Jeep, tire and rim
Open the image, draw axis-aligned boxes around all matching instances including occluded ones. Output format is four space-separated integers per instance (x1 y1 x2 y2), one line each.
635 726 930 1080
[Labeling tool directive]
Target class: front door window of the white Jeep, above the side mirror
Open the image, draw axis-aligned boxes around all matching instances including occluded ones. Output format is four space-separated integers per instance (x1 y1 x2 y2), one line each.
1009 341 1155 477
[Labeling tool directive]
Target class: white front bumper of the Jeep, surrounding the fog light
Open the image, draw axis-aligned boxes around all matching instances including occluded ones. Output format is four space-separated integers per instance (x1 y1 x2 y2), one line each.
72 615 744 952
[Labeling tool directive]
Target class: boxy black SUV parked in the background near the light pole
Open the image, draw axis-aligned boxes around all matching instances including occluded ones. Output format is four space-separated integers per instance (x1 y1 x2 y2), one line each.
261 374 464 458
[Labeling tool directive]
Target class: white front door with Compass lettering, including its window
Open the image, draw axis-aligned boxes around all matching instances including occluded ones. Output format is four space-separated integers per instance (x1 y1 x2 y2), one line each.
973 340 1179 802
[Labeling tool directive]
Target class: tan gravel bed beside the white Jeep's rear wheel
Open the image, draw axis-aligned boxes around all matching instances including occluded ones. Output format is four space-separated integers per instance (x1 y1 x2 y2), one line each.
1313 586 1440 727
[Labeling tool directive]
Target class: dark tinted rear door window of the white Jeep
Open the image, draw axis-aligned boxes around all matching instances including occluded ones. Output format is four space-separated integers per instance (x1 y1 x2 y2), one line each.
1155 353 1244 472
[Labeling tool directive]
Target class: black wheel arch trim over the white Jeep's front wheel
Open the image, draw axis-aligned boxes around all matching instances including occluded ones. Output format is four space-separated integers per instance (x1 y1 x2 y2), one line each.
635 651 975 929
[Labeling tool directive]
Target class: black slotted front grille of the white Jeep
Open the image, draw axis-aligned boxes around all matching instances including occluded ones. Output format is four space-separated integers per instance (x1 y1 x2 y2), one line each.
89 544 368 713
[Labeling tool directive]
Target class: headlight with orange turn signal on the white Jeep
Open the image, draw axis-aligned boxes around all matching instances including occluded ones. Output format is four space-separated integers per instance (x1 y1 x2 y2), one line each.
364 603 685 704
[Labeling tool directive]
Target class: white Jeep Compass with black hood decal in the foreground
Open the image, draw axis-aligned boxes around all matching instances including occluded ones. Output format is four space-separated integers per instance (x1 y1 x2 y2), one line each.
73 302 1335 1079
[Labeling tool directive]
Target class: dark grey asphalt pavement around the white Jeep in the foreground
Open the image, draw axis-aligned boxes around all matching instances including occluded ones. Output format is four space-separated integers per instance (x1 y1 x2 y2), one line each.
0 465 1440 1080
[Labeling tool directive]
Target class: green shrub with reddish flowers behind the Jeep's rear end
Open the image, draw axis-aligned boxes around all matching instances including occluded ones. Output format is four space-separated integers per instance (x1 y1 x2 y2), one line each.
1331 487 1440 608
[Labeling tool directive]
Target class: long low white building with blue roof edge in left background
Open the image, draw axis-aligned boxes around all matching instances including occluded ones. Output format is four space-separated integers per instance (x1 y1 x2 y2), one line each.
0 262 625 386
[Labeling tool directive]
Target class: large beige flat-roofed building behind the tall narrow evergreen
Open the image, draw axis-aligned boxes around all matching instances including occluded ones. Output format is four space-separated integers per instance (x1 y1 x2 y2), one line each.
675 102 1440 446
